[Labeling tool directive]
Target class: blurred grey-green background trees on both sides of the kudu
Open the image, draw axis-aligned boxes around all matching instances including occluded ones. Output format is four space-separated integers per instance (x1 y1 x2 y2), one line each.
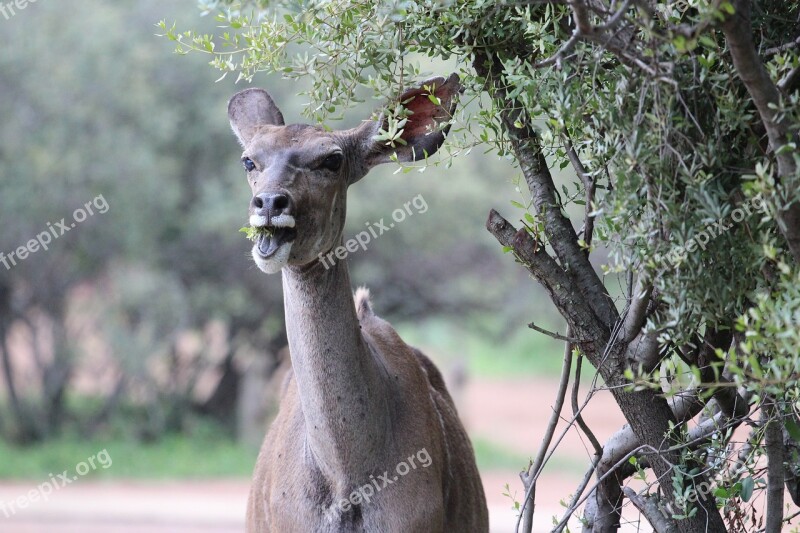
0 0 559 454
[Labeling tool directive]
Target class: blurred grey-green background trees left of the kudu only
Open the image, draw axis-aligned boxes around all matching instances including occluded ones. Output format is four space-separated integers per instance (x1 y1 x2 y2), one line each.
0 1 283 443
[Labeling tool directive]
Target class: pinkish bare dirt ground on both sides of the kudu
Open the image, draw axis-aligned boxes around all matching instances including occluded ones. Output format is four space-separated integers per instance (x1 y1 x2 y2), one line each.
0 378 664 533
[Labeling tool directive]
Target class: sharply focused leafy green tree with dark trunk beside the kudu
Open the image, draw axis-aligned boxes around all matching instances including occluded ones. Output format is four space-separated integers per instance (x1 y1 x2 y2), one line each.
170 0 800 532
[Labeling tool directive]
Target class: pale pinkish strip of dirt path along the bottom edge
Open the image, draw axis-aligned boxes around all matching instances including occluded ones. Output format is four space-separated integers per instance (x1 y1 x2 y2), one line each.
0 472 647 533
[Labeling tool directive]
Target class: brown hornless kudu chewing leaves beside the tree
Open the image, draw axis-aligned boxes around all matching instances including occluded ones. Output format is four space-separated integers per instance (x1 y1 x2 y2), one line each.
228 75 488 533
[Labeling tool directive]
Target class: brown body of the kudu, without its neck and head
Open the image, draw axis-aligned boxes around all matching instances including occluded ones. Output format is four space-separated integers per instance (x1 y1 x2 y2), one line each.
248 288 488 533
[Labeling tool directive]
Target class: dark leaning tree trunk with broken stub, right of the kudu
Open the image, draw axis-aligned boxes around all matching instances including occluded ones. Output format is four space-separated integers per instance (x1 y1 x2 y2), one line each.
473 44 726 533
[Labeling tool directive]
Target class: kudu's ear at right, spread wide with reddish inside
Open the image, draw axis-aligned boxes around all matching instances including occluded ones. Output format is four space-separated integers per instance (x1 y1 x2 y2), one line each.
365 74 461 167
